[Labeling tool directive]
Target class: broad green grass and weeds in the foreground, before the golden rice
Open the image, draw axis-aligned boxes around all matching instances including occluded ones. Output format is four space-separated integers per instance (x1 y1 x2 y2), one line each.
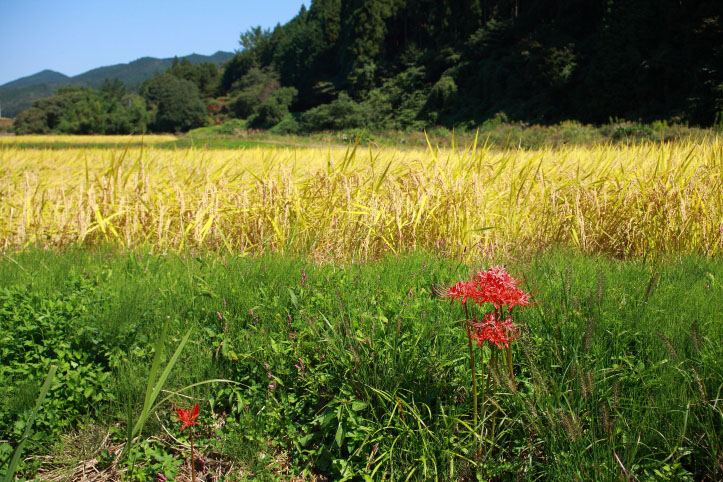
0 248 723 481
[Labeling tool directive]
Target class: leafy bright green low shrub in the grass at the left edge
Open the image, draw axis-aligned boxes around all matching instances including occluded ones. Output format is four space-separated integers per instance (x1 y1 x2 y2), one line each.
0 280 118 466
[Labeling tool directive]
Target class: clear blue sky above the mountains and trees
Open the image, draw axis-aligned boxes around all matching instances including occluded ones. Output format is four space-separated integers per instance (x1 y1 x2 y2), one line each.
0 0 309 85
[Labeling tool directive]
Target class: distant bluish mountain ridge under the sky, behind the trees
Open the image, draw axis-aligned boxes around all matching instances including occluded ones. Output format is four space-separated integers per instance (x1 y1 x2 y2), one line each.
0 50 234 117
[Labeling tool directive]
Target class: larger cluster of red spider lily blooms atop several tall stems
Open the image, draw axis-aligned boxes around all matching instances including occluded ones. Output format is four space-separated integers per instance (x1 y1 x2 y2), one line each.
445 266 531 348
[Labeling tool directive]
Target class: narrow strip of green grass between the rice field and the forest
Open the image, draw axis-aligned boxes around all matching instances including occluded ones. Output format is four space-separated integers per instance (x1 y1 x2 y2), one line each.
6 116 721 149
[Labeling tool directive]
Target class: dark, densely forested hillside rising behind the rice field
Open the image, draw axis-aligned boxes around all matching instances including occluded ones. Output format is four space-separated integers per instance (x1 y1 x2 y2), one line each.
11 0 723 133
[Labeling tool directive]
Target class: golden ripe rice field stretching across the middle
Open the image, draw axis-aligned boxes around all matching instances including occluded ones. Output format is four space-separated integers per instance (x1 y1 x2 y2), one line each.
0 136 723 260
